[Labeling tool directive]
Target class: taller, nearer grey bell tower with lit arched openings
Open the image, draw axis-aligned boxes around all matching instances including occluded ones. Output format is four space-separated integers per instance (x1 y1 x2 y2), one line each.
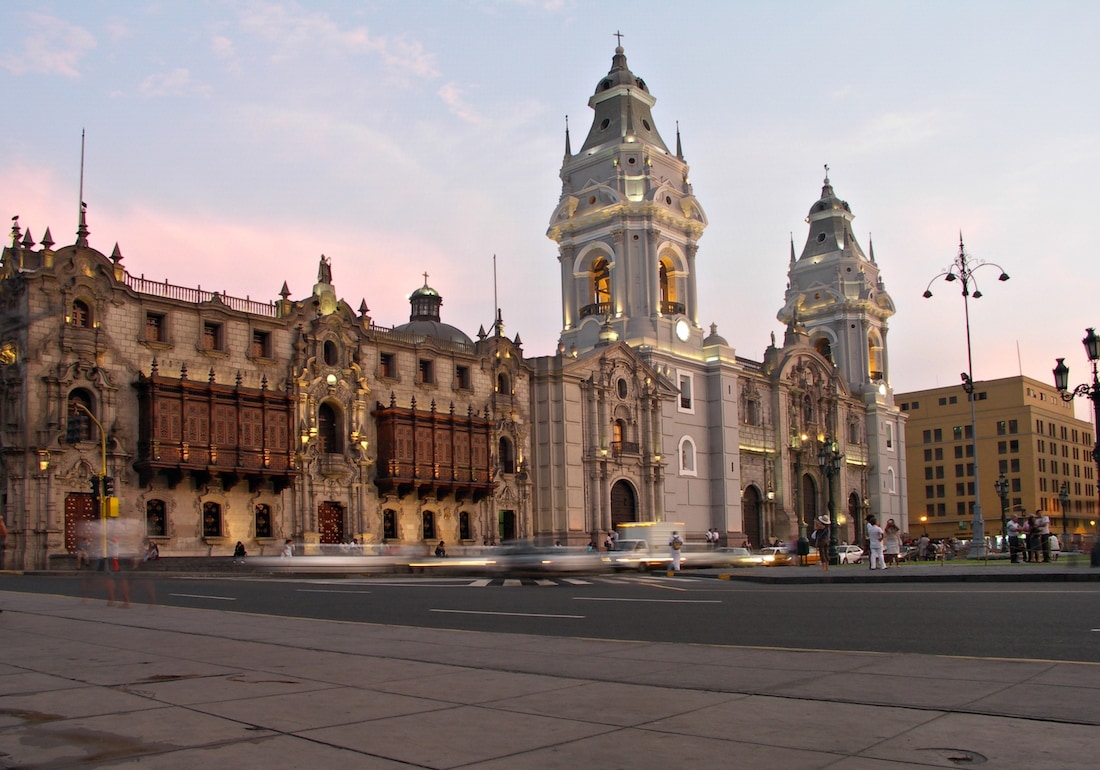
547 46 706 353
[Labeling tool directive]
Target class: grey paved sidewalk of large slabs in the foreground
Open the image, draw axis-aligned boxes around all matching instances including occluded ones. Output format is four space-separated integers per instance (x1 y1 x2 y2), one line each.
0 585 1100 770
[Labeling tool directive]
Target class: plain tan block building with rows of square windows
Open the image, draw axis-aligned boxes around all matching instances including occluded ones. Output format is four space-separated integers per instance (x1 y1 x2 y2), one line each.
898 376 1097 538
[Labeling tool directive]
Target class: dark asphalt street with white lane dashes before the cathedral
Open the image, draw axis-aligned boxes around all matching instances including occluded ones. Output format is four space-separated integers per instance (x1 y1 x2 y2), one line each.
2 568 1100 662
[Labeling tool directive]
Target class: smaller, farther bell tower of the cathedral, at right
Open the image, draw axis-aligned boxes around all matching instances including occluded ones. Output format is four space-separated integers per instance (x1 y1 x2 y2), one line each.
778 172 894 393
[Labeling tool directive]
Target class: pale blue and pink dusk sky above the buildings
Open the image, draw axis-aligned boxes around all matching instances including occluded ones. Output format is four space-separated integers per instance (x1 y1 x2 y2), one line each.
0 0 1100 416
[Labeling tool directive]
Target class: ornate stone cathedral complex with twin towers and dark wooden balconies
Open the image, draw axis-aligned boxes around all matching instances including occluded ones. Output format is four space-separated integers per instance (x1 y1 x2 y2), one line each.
0 47 908 569
